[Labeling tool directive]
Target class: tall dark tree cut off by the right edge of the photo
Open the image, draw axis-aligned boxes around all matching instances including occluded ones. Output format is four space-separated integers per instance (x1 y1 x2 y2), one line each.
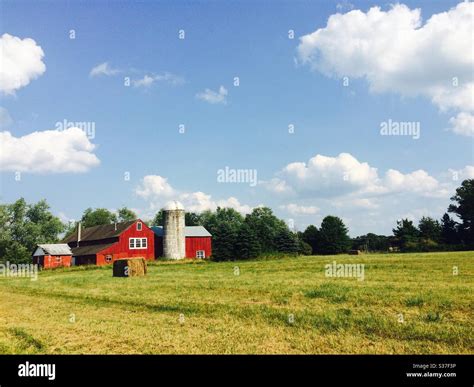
448 179 474 243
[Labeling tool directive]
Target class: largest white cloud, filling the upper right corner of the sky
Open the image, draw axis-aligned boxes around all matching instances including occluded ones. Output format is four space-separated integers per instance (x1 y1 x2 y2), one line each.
297 2 474 135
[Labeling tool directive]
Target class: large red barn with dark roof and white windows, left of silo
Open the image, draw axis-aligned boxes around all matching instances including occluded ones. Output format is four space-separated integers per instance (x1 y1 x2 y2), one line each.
64 219 155 265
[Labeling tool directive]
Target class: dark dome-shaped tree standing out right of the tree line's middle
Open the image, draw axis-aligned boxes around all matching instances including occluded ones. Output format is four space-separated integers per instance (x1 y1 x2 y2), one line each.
317 216 351 254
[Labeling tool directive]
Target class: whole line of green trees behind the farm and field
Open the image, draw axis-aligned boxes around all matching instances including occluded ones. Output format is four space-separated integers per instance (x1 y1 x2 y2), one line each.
0 179 474 263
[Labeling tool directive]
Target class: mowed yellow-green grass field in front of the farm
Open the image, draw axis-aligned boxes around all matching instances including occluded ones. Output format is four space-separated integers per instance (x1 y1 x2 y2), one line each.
0 252 474 354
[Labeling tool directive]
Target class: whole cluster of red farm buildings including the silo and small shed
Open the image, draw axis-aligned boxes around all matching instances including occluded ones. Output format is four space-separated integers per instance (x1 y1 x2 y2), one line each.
33 201 212 268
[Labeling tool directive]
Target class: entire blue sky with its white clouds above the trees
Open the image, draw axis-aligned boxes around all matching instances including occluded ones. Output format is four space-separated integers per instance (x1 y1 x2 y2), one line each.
0 1 474 235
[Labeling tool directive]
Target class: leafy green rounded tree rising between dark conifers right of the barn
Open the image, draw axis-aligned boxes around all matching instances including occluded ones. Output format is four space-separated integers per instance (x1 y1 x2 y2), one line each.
245 207 288 253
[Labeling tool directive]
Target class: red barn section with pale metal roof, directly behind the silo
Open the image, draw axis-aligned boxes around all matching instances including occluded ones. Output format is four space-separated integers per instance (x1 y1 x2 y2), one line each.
151 226 212 258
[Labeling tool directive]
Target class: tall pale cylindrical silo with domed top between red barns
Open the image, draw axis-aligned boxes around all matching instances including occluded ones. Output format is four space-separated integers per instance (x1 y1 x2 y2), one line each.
163 200 186 259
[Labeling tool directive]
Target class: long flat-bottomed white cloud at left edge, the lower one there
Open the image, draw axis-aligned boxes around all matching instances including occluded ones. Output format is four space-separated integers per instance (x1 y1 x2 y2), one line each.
0 128 100 173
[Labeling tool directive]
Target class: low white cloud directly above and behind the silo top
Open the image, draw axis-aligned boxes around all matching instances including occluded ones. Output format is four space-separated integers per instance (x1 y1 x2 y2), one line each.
135 175 253 214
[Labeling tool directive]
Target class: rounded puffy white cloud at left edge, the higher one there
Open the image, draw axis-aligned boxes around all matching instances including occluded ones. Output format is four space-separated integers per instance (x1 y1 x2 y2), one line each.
0 34 46 94
